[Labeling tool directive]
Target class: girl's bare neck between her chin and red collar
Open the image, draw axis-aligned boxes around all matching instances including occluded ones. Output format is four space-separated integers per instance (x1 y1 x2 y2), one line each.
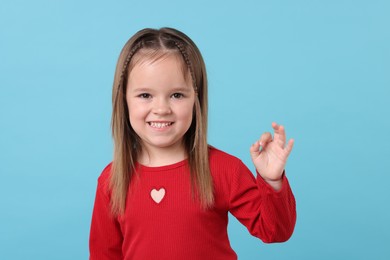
138 145 187 167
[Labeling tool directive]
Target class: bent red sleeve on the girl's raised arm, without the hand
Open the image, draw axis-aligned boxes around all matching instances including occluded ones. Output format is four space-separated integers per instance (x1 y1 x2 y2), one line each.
229 161 296 243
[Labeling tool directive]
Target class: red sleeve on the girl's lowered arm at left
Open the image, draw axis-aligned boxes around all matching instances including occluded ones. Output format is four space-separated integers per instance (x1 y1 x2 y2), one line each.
89 168 123 260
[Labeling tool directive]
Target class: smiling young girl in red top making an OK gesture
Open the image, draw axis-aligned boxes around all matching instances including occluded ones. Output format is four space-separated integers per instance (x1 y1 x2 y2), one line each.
90 28 296 260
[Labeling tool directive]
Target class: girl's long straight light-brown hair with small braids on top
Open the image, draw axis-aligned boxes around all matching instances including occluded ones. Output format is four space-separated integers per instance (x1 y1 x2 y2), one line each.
109 28 214 216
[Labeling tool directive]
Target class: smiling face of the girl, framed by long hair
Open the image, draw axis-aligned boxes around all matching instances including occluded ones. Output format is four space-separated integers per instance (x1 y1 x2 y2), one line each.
126 55 195 160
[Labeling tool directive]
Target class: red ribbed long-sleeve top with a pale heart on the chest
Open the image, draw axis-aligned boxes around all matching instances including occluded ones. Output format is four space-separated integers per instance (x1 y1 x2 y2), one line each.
89 148 296 260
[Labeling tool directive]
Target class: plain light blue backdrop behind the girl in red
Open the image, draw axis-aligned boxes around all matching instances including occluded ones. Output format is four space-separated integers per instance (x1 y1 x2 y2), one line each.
0 0 390 259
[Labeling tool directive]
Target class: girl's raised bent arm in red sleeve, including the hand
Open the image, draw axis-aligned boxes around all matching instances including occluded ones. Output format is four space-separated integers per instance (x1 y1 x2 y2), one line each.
230 123 296 243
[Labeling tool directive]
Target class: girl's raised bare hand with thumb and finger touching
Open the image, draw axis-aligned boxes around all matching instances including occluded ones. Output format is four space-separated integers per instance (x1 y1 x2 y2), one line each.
250 123 294 190
